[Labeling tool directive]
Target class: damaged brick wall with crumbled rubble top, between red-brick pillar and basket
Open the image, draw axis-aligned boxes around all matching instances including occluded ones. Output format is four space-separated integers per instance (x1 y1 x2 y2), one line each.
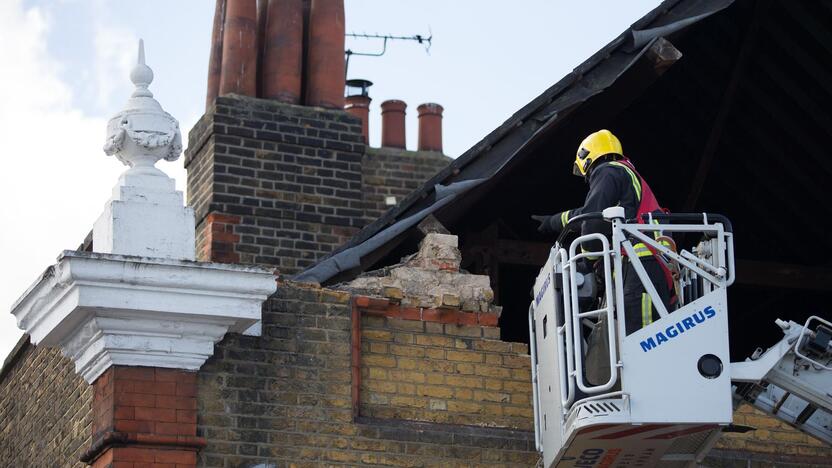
193 234 538 467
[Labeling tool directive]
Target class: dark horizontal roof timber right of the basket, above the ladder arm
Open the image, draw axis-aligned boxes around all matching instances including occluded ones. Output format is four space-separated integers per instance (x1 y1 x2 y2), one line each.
737 260 832 292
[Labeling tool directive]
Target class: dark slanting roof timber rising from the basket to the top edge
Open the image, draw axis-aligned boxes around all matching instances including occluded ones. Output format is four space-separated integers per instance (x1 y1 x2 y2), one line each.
682 0 770 212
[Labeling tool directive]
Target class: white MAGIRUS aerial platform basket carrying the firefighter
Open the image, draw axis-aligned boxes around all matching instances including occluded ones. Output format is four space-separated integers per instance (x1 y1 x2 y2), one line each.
529 207 734 467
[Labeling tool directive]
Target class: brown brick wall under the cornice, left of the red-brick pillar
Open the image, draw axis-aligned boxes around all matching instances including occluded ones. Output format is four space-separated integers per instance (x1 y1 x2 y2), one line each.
0 342 93 468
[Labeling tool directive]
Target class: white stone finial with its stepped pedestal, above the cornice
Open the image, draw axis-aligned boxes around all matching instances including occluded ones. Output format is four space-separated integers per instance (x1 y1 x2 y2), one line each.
92 40 195 260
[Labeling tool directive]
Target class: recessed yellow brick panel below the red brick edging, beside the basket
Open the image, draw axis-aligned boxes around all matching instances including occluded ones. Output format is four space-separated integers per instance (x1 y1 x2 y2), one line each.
360 316 534 431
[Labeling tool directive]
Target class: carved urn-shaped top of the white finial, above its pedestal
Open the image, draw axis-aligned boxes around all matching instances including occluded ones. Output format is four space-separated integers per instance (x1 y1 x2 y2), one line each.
104 39 182 176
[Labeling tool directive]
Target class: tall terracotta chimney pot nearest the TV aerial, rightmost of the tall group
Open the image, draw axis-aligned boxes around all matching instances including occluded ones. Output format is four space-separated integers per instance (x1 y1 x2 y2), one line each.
306 0 346 109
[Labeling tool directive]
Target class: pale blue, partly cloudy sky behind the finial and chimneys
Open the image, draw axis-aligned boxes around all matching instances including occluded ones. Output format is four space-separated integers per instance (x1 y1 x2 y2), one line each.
0 0 660 359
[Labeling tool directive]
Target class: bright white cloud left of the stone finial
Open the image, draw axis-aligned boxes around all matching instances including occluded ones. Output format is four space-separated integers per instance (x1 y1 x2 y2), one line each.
0 0 125 357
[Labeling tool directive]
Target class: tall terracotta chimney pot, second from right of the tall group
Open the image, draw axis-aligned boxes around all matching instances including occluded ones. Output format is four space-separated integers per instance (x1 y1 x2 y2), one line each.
261 0 303 104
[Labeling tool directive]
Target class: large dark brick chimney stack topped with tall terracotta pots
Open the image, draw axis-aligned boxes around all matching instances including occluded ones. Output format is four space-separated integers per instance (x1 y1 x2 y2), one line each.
192 0 448 275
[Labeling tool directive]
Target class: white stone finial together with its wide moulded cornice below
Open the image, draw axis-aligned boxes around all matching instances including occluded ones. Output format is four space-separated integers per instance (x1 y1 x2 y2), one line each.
12 42 276 383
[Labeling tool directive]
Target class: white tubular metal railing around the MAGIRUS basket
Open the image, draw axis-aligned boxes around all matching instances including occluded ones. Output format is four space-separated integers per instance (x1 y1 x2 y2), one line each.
552 208 736 414
